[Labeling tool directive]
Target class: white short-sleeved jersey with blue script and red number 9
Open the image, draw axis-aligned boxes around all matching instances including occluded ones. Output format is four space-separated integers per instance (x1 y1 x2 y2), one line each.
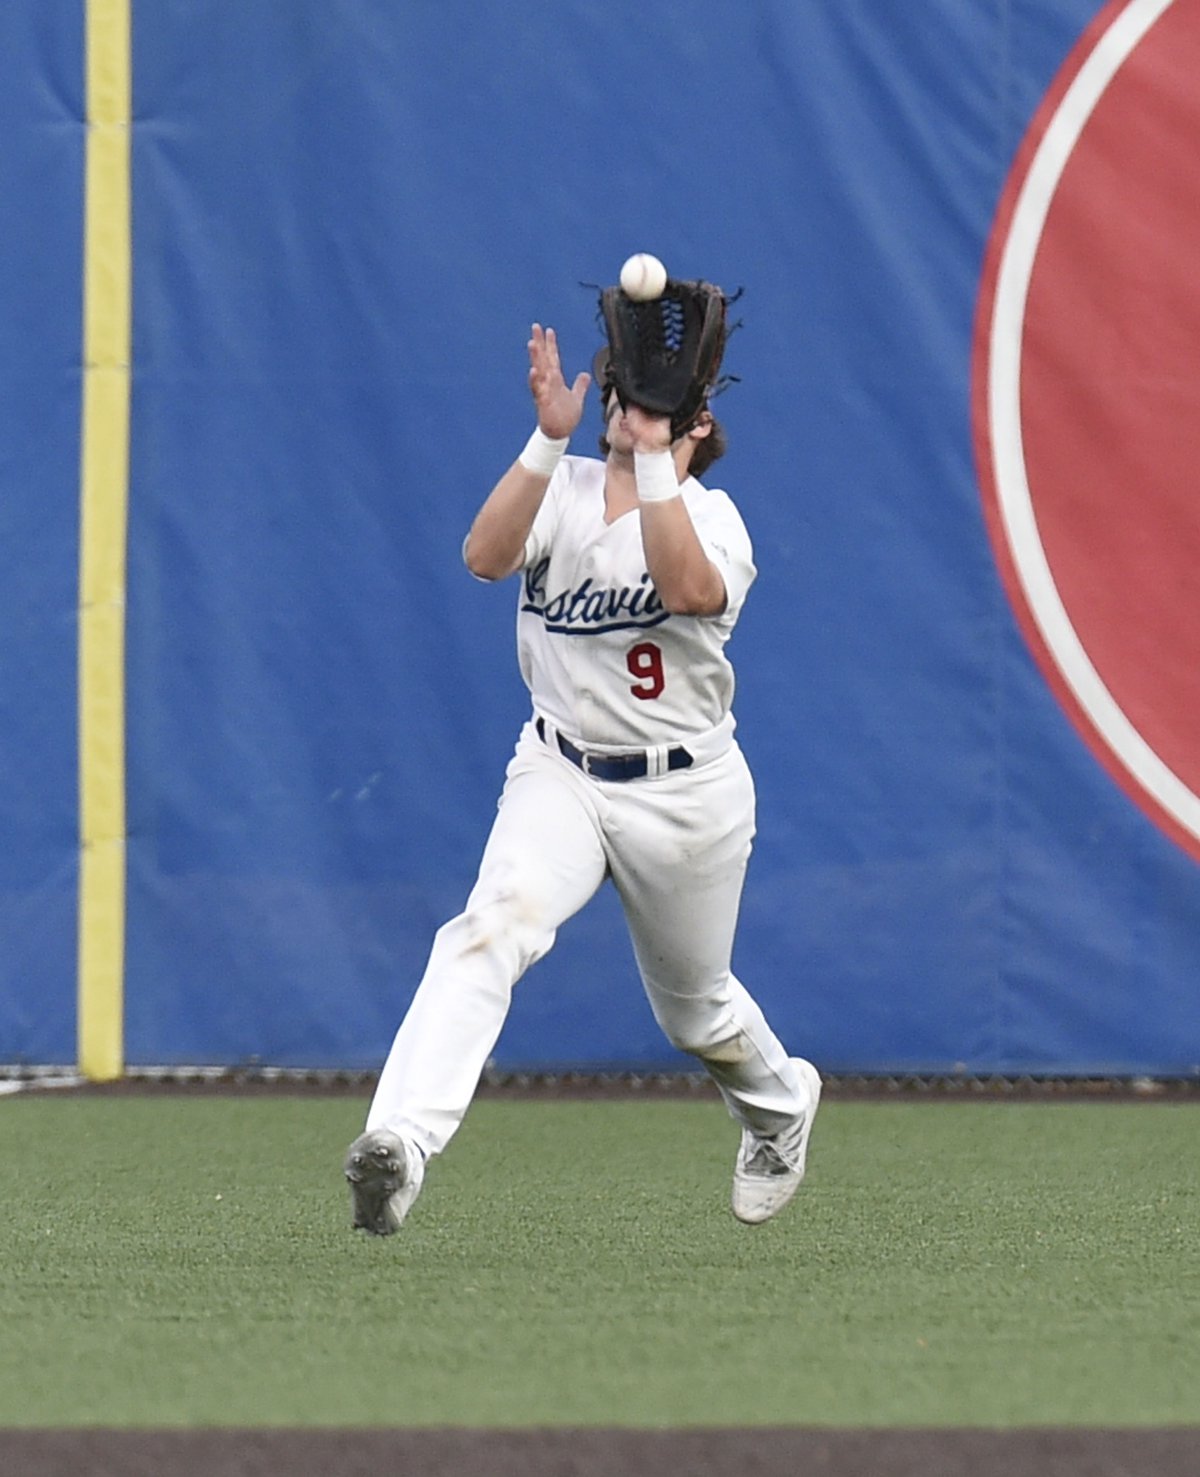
517 456 755 749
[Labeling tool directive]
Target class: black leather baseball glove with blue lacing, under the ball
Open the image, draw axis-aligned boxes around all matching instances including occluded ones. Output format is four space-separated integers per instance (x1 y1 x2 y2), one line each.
593 278 729 439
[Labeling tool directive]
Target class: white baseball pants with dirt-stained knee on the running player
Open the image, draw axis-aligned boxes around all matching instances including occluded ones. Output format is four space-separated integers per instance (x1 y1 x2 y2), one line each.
367 724 808 1155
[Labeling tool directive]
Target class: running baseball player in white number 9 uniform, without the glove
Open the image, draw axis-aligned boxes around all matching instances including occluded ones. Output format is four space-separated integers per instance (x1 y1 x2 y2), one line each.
344 284 820 1236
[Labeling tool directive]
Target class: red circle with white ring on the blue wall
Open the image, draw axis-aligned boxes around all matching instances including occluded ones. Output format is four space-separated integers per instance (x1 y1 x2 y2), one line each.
972 0 1200 860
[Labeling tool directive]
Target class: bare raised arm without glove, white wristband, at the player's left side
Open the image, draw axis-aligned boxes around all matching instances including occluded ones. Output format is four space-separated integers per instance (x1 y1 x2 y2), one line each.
463 323 591 579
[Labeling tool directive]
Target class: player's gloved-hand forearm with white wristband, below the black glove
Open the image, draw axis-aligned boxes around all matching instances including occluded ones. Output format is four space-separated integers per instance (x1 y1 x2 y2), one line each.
625 405 729 616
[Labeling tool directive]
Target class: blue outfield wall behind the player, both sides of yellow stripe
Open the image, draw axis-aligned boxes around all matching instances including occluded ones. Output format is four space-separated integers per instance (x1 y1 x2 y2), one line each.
0 0 1200 1075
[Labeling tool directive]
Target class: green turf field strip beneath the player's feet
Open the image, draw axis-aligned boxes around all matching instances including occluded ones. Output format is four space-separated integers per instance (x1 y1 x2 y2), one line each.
0 1094 1200 1427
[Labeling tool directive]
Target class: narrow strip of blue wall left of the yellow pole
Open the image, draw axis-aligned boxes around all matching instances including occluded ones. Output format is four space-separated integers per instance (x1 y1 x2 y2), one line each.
0 0 83 1062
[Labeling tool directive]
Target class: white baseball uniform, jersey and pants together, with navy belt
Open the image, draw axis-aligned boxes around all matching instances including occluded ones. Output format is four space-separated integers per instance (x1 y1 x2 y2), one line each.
367 456 808 1155
